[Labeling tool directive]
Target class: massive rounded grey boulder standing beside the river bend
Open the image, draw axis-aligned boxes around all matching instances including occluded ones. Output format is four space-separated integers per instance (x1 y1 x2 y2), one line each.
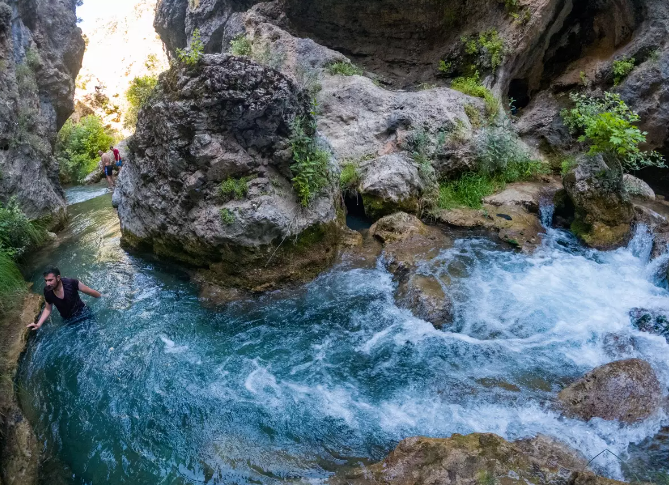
115 55 339 291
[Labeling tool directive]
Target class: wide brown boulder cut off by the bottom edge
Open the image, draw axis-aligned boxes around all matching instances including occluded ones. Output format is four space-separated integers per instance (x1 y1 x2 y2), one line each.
330 433 622 485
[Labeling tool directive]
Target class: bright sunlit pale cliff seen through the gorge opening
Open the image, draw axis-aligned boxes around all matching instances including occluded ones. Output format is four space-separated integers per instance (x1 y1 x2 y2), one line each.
75 0 168 136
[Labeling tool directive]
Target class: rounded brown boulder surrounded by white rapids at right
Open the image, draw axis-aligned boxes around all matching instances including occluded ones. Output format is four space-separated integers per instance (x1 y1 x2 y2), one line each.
558 359 662 423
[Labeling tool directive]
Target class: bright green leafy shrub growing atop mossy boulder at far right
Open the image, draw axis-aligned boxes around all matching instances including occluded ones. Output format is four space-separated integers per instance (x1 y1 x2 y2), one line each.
561 92 664 171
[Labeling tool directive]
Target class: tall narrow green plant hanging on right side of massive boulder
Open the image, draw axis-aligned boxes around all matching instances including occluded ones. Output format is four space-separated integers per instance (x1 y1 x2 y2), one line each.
290 114 330 207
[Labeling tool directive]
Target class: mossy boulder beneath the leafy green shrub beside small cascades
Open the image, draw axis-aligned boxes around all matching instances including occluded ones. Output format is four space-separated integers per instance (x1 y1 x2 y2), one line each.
563 155 634 249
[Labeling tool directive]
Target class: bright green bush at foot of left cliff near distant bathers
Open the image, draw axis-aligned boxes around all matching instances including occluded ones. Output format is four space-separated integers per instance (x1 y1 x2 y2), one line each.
56 115 114 183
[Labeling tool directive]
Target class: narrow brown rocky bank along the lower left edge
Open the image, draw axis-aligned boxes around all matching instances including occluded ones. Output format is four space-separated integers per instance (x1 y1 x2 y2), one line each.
0 293 42 485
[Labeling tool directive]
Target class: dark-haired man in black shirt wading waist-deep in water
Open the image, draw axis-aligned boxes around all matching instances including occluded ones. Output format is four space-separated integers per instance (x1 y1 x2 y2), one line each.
28 268 102 330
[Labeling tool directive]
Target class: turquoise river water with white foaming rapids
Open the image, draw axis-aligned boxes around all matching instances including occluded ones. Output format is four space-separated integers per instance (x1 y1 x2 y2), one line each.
19 188 669 484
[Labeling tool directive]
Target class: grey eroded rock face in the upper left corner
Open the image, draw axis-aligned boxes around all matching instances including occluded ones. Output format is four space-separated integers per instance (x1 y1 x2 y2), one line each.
0 0 84 223
